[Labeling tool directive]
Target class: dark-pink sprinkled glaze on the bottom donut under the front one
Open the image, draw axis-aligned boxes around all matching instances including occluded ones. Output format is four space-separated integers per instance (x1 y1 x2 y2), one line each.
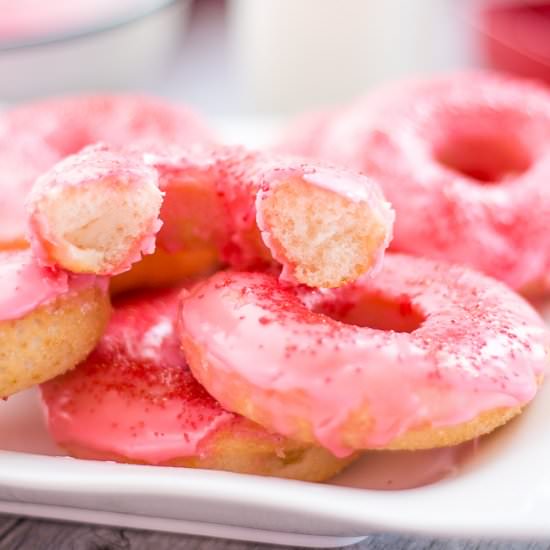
41 290 239 464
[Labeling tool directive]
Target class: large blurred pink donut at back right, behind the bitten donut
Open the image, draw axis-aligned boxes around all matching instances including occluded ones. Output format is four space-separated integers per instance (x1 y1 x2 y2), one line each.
280 73 550 292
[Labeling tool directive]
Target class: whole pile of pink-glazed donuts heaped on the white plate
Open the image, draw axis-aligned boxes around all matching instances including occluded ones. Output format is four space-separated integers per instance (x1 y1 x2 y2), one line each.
0 76 550 481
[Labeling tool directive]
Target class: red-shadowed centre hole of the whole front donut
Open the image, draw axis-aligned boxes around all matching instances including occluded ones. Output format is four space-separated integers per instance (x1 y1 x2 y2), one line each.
316 296 426 333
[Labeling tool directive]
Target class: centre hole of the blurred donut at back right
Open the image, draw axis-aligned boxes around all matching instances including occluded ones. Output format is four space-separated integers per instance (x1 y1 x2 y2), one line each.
435 132 532 185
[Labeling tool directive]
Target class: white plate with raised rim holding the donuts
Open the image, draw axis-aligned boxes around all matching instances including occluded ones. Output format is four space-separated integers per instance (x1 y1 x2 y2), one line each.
0 118 550 548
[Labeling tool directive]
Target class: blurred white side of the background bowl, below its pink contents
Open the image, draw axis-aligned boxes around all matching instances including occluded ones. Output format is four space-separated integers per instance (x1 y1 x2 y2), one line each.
0 0 189 101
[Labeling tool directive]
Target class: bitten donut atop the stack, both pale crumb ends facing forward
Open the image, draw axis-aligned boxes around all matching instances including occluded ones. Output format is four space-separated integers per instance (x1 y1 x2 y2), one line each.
30 147 393 291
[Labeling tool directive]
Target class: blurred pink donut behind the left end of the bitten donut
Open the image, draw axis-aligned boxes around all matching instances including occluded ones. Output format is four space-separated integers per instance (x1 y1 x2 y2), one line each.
0 95 214 250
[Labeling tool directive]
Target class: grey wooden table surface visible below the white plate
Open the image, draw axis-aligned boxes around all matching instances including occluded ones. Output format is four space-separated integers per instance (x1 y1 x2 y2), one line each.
0 515 550 550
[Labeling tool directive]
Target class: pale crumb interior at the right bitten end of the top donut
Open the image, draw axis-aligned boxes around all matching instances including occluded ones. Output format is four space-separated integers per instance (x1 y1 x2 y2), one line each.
261 178 387 288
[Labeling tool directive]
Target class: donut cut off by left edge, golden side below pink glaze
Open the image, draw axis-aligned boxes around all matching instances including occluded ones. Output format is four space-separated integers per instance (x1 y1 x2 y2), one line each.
0 249 110 399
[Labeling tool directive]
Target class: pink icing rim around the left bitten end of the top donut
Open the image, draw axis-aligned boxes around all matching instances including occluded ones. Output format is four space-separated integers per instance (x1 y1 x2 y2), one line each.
28 144 162 275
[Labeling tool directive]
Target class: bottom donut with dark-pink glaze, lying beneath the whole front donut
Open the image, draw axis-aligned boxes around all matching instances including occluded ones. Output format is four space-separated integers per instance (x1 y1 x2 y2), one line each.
41 288 356 481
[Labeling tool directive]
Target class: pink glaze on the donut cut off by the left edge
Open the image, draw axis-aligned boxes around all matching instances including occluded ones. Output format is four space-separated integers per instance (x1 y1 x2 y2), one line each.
0 249 108 321
